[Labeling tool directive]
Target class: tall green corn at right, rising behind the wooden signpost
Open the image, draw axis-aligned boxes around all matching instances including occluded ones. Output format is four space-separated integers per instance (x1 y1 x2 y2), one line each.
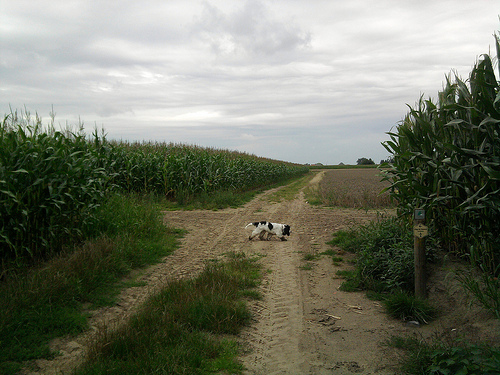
384 33 500 275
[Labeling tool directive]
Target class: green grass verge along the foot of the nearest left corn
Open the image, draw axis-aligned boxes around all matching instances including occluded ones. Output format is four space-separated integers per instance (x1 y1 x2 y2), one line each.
0 196 179 374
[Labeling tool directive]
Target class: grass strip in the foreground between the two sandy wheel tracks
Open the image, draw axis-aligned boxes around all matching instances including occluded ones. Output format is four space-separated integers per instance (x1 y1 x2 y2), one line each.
76 253 261 375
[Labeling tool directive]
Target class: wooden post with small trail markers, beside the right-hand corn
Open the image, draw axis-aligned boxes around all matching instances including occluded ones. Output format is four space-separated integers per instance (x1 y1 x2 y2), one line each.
413 209 428 298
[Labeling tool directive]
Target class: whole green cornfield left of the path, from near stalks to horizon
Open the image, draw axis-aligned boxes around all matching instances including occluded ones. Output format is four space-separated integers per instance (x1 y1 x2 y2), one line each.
0 110 307 269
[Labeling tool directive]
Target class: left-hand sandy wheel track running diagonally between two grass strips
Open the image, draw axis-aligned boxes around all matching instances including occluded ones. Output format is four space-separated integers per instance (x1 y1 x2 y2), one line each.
28 189 286 375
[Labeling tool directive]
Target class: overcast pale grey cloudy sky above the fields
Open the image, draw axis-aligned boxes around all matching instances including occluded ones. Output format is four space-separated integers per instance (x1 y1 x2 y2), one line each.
0 0 500 164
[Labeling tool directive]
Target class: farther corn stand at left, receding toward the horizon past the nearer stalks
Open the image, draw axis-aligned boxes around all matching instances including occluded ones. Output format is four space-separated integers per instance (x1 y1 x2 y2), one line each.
113 143 306 201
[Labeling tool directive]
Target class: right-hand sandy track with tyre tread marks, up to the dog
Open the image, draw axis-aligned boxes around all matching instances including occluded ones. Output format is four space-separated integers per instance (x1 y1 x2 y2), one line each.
238 187 402 375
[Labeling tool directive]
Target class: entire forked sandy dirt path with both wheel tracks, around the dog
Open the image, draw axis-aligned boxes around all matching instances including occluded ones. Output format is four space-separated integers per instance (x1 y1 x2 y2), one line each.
30 173 407 375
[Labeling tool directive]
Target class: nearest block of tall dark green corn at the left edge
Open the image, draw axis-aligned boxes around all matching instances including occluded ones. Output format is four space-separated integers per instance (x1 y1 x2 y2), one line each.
0 112 106 258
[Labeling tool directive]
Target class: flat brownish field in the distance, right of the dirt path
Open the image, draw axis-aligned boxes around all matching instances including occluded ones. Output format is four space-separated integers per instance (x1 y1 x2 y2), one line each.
309 168 394 209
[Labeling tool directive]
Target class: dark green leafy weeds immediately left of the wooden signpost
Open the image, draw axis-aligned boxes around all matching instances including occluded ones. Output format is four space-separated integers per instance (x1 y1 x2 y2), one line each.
329 218 436 323
